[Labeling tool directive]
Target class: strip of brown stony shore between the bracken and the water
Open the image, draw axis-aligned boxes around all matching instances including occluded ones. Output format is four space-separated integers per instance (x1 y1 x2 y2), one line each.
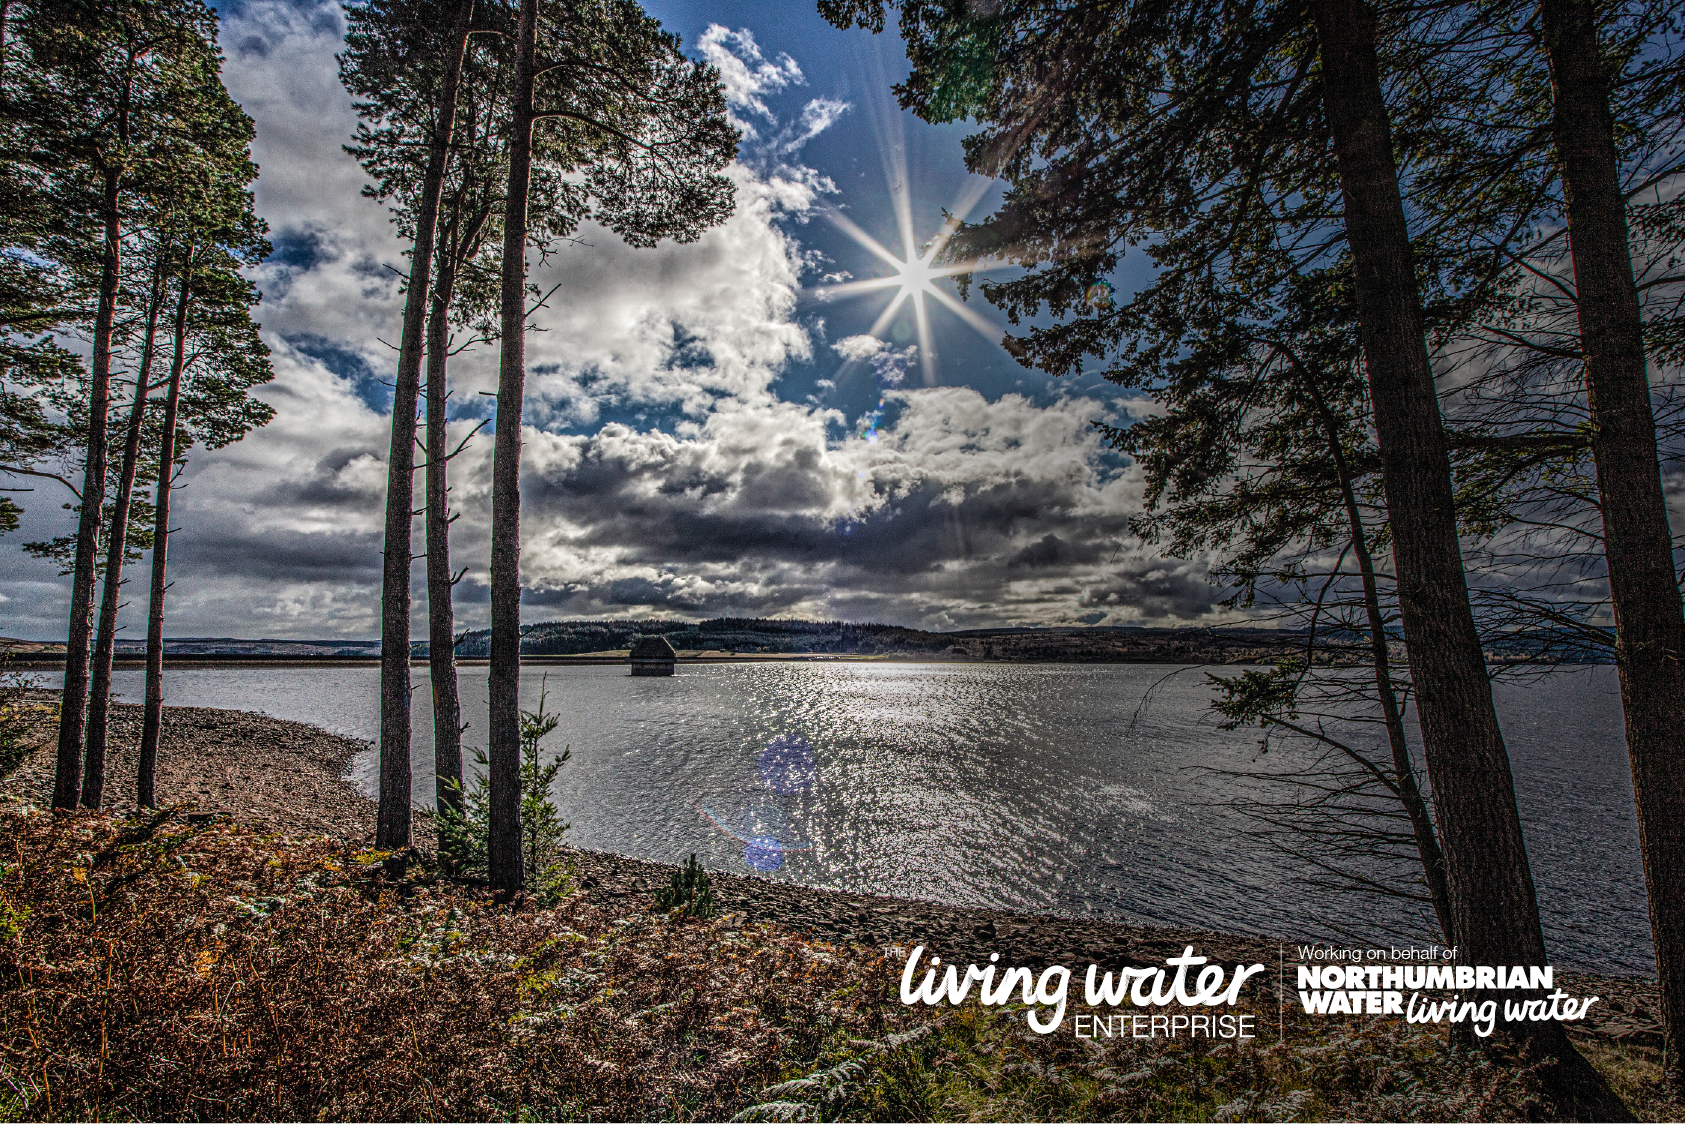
0 691 1660 1045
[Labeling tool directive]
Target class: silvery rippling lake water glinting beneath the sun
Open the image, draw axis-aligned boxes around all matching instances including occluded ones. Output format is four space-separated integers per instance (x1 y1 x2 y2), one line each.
79 662 1651 972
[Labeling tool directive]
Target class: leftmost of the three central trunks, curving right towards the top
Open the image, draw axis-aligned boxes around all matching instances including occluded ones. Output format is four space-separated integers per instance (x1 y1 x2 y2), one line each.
374 0 473 851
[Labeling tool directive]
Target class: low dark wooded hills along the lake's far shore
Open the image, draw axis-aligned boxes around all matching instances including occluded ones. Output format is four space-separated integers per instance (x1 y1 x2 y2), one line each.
438 617 1301 664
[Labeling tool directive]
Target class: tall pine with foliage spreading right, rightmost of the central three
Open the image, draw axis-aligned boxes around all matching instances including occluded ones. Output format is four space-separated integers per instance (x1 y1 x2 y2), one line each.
487 0 736 893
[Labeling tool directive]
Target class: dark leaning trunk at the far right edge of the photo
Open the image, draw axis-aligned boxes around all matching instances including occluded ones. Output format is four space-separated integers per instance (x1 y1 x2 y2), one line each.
1538 0 1685 1085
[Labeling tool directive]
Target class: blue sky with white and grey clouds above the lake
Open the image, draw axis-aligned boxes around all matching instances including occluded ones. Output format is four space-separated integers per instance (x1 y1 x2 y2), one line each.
0 0 1222 639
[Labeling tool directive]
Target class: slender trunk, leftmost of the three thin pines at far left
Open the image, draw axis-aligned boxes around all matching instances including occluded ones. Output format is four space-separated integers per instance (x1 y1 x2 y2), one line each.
52 167 123 809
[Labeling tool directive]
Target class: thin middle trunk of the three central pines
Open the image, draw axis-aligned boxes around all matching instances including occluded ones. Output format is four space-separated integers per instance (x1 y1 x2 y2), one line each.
426 254 462 835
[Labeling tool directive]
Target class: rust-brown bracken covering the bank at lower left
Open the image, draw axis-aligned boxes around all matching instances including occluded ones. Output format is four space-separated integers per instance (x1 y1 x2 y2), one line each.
0 811 895 1119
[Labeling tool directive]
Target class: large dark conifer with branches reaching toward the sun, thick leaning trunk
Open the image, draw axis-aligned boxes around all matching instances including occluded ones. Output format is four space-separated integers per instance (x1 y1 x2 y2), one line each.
821 0 1671 1112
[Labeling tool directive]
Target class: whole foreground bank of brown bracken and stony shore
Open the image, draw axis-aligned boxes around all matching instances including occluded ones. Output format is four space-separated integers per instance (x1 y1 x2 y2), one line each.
0 694 1685 1121
